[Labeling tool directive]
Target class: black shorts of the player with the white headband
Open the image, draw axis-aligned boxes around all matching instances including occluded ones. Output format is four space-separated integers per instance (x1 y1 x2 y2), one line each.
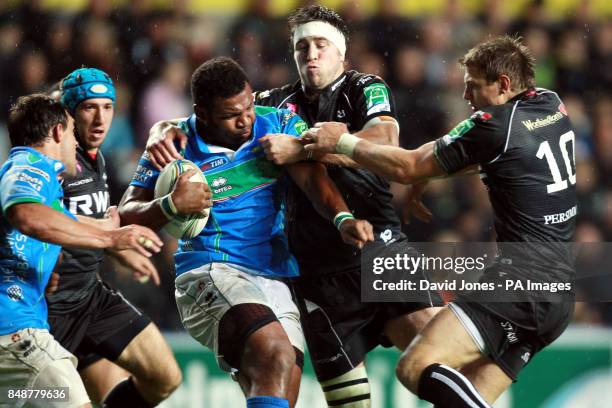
290 242 443 381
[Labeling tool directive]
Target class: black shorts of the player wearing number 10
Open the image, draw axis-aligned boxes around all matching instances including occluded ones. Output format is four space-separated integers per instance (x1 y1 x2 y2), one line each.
451 264 574 381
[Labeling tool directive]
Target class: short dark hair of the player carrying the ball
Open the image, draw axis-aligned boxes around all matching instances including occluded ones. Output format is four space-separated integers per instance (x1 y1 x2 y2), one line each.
191 57 249 111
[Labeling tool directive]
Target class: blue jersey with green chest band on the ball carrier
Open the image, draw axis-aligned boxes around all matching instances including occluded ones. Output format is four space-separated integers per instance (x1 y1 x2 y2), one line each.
130 106 307 277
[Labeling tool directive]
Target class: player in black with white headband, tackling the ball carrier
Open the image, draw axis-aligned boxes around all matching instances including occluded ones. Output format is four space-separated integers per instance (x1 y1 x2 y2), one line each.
148 5 442 408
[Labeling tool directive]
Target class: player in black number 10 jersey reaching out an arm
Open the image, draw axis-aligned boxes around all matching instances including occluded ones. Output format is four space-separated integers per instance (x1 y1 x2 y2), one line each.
305 36 577 408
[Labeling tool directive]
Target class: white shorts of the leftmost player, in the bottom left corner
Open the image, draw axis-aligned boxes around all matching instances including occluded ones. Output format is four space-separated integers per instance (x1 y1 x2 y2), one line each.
0 329 89 408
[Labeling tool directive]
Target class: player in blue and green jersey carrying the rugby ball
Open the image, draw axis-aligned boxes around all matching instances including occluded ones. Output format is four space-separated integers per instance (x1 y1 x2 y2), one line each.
120 57 373 408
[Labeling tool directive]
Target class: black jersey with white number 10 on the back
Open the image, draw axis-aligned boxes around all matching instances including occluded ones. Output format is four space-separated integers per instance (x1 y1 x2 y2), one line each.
435 88 577 278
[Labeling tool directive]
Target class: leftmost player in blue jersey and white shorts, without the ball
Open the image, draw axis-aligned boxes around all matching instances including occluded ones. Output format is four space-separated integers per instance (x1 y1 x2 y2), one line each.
0 94 162 407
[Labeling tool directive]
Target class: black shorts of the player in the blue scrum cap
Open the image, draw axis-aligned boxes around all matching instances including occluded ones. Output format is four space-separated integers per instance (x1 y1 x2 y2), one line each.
49 281 151 370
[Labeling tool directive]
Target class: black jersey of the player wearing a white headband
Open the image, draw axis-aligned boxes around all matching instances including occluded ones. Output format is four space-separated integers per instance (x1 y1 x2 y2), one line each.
255 71 401 276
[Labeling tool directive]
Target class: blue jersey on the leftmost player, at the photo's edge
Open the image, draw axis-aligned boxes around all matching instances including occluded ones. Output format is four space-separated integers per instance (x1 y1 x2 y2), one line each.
0 147 74 335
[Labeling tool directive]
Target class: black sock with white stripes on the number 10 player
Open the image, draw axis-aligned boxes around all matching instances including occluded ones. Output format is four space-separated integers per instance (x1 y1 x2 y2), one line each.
418 364 490 408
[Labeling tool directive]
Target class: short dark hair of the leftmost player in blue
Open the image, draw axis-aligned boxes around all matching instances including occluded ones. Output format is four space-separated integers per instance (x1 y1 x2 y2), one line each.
7 94 68 146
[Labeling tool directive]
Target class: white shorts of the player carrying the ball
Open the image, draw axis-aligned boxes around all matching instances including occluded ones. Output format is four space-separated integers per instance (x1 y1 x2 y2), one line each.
175 263 304 371
